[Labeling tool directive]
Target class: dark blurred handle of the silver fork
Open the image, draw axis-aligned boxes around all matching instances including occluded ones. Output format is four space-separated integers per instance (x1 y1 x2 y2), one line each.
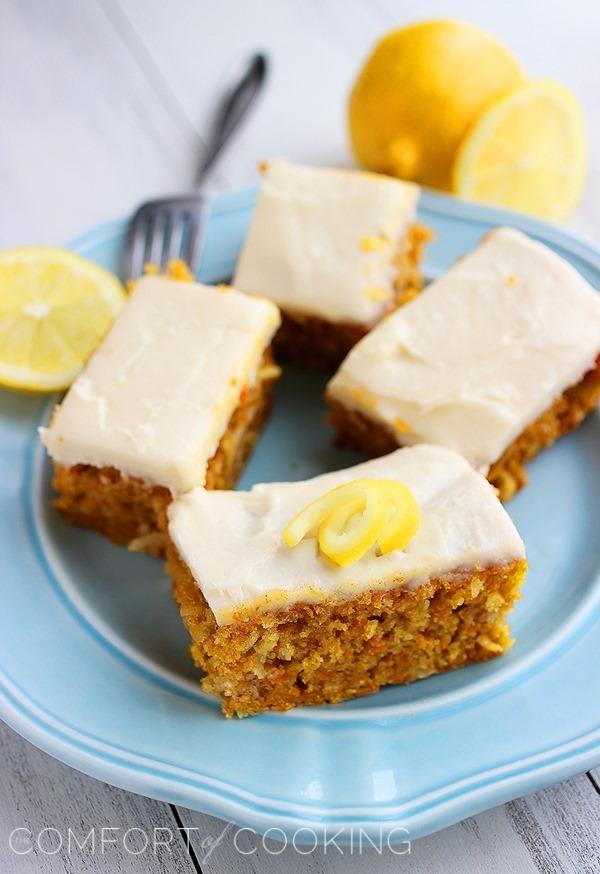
196 54 267 188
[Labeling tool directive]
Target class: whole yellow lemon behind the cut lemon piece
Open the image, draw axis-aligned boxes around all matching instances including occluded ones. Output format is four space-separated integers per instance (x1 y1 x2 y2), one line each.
349 19 525 190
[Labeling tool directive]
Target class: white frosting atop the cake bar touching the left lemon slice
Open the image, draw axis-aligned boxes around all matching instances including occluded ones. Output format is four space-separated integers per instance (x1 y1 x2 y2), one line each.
42 276 280 492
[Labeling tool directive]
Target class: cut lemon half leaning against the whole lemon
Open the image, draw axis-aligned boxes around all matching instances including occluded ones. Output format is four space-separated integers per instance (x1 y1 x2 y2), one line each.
452 80 586 220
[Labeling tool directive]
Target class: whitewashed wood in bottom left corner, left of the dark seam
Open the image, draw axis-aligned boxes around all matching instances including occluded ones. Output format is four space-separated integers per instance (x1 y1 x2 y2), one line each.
0 722 197 874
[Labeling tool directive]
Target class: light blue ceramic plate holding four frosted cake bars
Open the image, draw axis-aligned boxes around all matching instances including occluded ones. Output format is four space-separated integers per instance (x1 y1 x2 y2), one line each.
0 192 600 837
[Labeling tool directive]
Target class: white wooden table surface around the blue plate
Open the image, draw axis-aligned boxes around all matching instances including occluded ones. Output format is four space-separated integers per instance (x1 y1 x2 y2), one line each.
0 0 600 874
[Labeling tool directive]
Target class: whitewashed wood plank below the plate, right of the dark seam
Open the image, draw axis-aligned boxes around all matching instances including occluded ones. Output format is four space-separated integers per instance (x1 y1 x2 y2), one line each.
179 775 600 874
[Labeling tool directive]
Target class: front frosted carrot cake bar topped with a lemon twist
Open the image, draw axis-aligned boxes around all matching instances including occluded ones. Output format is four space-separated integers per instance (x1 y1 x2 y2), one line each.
167 445 526 716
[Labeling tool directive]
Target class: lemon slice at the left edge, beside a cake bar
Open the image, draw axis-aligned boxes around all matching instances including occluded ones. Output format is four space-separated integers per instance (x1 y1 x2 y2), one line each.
0 246 126 391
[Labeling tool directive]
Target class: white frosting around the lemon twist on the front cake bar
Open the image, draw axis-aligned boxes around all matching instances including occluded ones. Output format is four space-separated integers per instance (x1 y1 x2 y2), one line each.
169 445 525 624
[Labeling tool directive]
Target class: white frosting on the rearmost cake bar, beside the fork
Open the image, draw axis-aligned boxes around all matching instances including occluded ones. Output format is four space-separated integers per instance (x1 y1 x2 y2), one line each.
234 160 419 325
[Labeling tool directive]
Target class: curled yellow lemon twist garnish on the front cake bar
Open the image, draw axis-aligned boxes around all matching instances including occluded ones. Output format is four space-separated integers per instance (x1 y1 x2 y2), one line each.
283 479 421 567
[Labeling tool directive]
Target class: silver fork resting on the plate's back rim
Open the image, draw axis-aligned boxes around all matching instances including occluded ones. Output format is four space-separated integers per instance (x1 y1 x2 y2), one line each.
123 54 267 279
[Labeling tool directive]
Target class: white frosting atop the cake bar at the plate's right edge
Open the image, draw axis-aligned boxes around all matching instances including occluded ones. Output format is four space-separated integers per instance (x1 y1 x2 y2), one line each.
328 228 600 469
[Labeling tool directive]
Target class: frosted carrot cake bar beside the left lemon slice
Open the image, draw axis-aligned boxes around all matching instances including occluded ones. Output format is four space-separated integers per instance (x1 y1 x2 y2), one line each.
41 276 280 554
